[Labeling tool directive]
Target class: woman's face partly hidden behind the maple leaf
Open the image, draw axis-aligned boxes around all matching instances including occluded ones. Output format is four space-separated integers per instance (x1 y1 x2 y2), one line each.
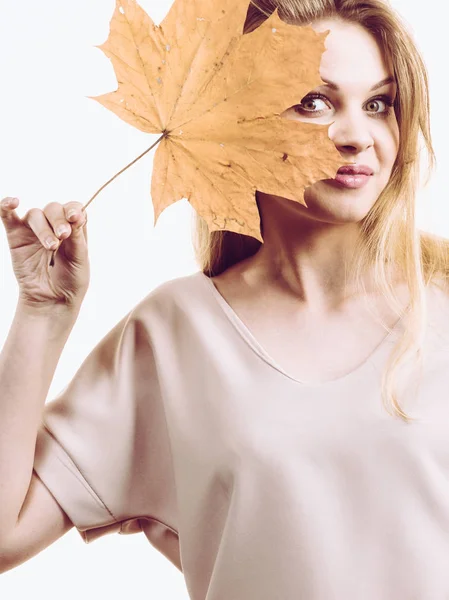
272 19 399 223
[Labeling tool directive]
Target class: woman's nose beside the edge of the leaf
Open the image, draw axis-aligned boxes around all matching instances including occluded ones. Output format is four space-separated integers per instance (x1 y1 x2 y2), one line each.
328 111 374 154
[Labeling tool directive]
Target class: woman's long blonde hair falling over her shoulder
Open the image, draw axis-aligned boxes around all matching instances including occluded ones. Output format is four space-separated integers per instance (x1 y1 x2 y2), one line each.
192 0 449 422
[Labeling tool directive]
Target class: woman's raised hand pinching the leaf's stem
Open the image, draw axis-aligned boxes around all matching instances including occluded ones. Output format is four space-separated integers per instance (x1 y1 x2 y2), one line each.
0 198 90 311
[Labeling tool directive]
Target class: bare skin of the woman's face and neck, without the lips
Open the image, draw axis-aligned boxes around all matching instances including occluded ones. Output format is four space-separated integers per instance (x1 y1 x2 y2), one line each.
240 18 399 314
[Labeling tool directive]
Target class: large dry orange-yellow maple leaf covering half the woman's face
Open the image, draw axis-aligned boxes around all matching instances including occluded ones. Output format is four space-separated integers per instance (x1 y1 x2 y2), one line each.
91 0 345 242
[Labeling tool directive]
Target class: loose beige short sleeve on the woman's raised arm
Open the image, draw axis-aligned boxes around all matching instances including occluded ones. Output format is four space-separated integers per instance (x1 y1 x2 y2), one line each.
34 309 176 543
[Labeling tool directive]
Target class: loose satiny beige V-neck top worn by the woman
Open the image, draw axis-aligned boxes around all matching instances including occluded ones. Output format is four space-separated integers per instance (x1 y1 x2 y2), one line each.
34 272 449 600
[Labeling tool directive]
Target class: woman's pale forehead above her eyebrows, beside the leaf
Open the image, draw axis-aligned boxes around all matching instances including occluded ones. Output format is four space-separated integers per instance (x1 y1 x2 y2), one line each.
311 19 393 89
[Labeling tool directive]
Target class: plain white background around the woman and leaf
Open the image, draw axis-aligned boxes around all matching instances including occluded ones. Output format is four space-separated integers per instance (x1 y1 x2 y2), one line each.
0 0 449 600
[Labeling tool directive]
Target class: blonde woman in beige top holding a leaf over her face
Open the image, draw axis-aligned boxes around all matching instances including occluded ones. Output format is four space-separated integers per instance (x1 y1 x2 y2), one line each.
0 0 449 600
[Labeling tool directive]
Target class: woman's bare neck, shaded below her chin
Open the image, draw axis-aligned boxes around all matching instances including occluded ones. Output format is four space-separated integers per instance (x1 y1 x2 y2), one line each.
252 195 373 313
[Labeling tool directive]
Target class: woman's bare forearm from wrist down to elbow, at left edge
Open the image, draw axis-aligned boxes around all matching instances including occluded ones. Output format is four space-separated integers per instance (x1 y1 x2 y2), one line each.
0 304 78 537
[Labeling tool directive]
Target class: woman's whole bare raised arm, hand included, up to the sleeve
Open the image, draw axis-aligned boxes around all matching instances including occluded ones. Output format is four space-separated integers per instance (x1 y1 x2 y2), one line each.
0 197 90 573
